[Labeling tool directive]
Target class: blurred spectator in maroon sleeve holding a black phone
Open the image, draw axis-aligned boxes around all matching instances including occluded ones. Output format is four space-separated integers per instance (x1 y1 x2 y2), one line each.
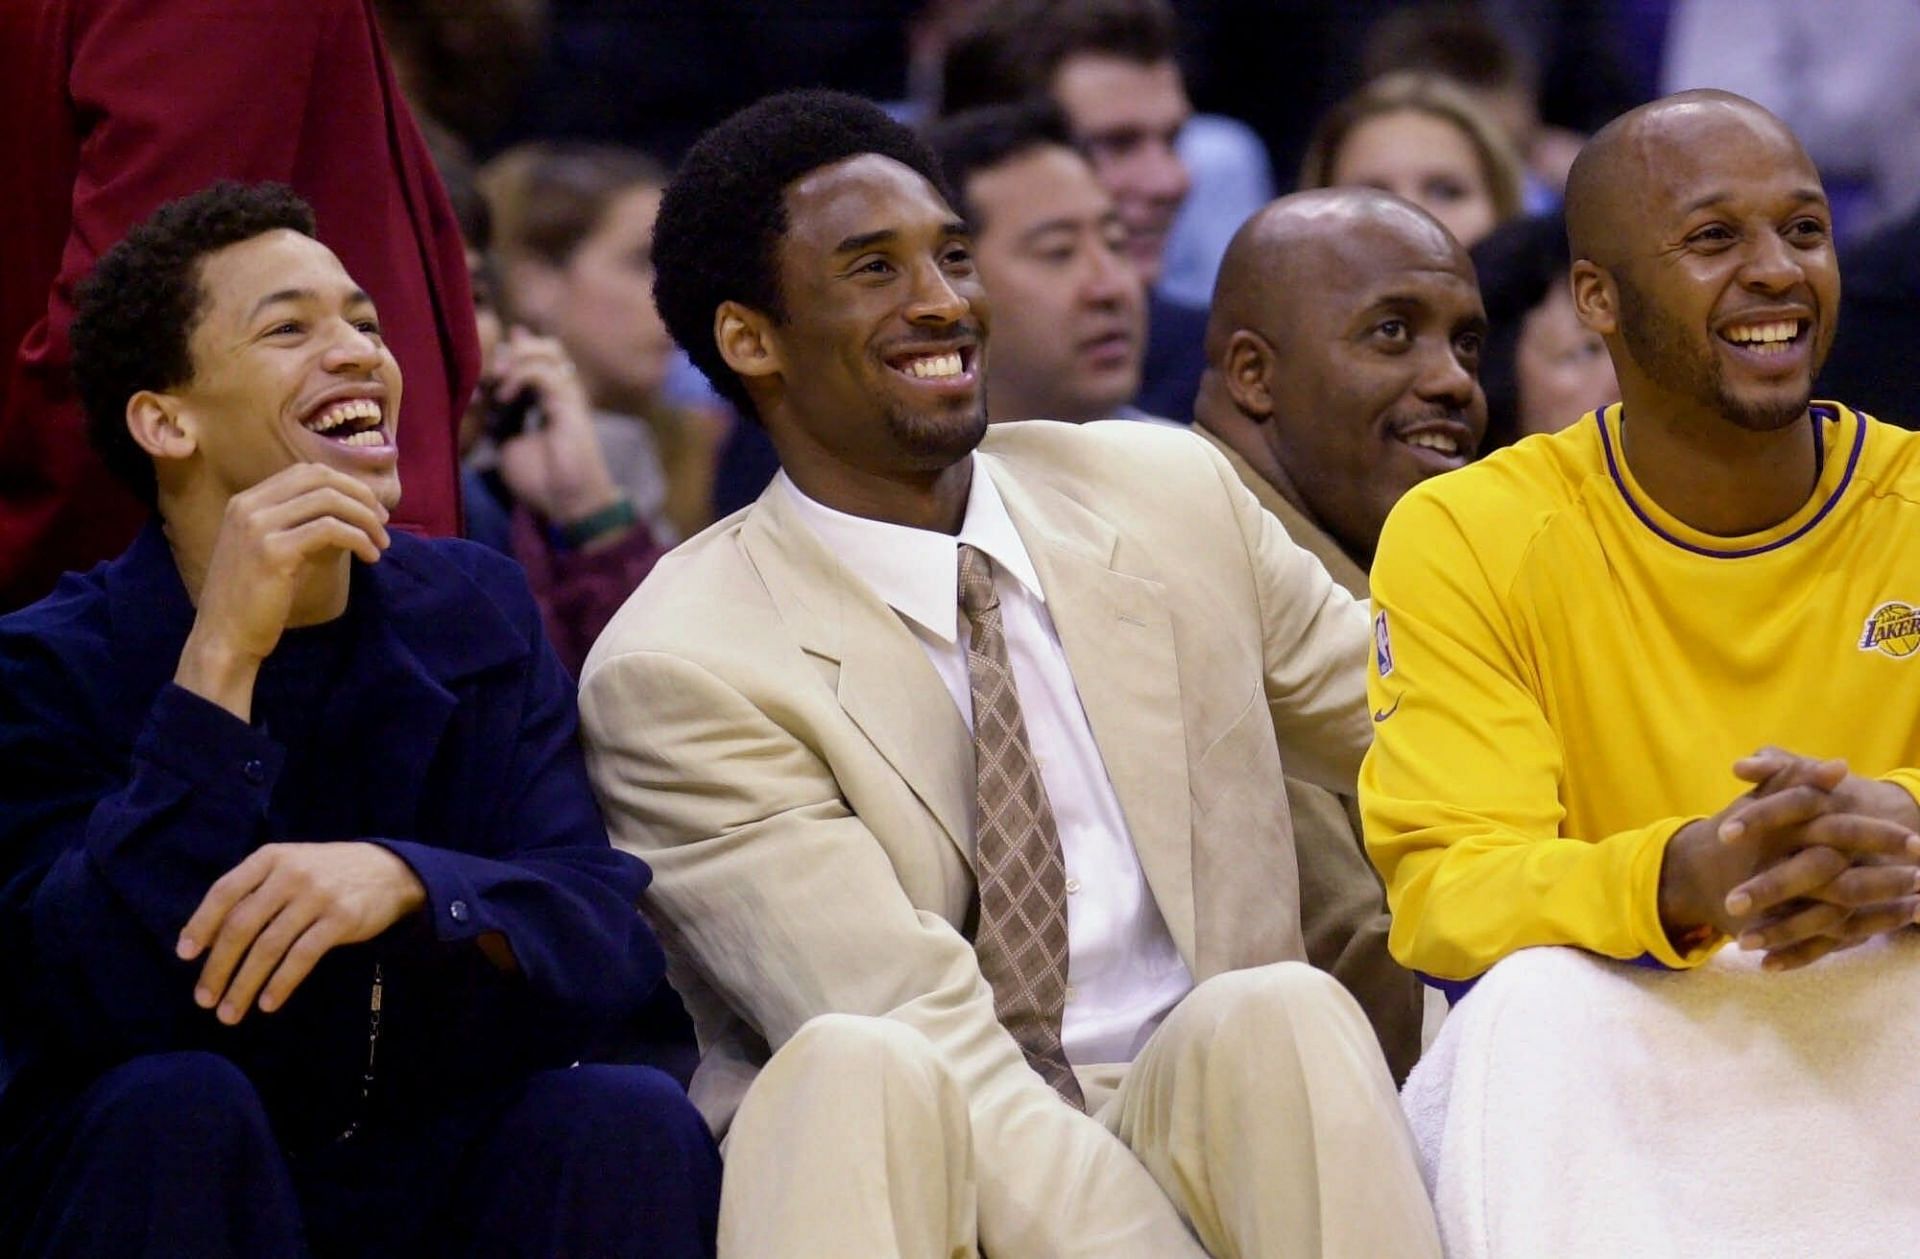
434 144 664 674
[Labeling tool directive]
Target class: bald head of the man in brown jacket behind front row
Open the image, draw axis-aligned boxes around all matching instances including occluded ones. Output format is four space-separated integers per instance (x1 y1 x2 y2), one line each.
1194 188 1486 566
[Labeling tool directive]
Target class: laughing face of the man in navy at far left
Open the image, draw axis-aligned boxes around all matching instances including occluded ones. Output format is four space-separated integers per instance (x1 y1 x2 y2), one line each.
161 230 401 509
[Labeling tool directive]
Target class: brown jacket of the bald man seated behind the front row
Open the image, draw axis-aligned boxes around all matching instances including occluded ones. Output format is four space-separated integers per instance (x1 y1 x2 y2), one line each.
1198 428 1427 1081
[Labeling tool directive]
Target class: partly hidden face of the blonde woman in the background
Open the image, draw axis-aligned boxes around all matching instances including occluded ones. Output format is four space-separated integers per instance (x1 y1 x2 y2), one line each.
1332 109 1500 248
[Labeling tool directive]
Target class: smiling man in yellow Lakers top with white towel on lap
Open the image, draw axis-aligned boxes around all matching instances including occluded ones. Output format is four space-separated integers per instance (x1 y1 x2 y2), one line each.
1361 92 1920 1259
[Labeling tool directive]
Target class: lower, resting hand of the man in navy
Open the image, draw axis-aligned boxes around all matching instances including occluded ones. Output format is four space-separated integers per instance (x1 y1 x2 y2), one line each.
179 843 426 1025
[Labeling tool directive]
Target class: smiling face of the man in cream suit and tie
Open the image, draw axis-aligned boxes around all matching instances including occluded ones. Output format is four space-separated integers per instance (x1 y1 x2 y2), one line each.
741 154 989 489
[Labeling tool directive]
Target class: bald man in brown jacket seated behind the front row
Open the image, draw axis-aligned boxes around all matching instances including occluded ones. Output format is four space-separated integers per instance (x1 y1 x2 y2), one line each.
1194 188 1486 1079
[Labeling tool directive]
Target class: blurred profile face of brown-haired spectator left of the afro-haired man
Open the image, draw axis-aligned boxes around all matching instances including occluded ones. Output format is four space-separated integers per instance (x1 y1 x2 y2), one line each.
543 186 674 413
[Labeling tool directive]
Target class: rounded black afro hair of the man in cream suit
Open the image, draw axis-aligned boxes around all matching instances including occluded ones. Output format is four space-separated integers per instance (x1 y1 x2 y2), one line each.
653 90 954 418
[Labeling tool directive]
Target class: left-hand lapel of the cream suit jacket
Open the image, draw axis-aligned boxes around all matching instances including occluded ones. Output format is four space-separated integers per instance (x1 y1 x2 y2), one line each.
741 486 973 867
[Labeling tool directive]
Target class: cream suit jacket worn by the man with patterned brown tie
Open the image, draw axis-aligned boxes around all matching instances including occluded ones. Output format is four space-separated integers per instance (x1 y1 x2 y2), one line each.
582 422 1371 1257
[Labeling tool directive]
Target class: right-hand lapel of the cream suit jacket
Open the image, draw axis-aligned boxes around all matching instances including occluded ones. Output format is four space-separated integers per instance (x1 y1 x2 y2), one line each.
977 455 1196 963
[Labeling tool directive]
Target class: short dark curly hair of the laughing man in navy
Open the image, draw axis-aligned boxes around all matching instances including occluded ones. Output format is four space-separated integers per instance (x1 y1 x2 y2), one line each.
67 180 317 507
